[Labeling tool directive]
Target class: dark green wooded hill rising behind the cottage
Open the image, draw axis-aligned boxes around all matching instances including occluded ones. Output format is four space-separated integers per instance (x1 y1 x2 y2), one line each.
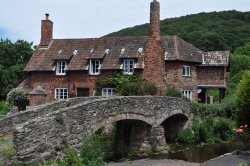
106 10 250 51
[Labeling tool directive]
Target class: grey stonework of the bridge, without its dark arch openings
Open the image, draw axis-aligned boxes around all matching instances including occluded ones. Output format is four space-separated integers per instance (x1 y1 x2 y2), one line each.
13 96 192 162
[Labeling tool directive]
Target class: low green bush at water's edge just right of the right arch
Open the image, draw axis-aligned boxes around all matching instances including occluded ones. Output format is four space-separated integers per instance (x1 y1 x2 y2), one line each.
177 128 195 143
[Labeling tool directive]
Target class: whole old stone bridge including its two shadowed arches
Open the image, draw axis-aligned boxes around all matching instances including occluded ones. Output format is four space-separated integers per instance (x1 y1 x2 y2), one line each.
3 96 192 162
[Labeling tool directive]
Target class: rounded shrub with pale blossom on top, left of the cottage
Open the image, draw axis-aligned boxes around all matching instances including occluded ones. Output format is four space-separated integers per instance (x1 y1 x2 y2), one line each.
7 88 29 111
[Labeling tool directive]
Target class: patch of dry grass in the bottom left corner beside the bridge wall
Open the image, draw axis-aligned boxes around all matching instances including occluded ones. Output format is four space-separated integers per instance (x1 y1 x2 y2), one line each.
0 133 15 162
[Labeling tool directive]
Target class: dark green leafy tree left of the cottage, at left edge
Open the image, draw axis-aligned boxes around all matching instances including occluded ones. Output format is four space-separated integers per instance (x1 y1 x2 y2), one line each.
0 39 33 100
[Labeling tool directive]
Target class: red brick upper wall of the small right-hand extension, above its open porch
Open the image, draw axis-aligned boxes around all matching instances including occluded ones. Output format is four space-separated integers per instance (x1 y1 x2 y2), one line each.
197 66 226 85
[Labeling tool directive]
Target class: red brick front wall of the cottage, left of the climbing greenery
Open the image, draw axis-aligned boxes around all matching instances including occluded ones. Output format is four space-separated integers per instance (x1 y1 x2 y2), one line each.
27 70 115 105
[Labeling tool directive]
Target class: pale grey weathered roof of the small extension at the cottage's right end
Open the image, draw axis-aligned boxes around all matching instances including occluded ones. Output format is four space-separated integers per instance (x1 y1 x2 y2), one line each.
203 51 230 66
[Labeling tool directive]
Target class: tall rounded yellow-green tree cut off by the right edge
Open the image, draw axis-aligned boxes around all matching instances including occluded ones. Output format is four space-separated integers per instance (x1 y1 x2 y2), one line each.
236 70 250 125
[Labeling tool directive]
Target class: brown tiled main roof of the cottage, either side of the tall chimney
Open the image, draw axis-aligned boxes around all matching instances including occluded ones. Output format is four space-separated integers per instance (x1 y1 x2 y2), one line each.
24 36 227 71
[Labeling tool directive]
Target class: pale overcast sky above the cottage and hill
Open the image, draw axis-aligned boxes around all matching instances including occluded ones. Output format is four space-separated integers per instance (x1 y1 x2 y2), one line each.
0 0 250 44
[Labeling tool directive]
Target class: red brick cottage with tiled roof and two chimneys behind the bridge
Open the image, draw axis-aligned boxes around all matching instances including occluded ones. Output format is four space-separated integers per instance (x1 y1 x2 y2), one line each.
20 0 229 105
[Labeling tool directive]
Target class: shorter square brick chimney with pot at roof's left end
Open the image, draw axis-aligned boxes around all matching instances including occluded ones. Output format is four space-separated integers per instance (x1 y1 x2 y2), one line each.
40 13 53 47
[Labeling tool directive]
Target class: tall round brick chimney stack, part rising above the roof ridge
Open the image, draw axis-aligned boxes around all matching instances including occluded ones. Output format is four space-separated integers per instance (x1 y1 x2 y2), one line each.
149 0 160 40
